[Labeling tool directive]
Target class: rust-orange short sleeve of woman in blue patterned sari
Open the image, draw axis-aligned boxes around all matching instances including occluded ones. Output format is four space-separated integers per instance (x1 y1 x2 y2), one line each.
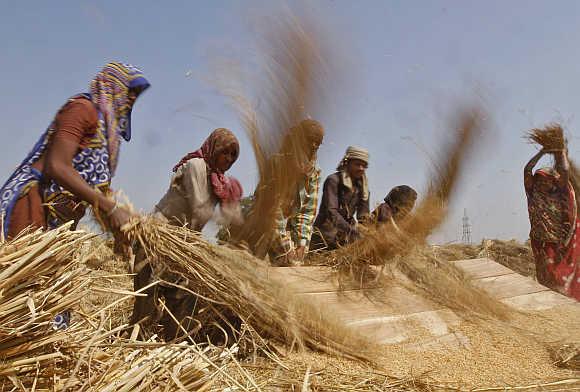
54 99 98 147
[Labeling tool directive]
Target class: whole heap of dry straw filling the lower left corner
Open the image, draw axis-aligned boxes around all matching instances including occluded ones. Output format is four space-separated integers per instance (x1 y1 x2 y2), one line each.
0 225 243 391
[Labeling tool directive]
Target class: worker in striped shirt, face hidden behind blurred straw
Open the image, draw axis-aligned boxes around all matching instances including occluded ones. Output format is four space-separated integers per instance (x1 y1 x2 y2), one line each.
268 119 324 266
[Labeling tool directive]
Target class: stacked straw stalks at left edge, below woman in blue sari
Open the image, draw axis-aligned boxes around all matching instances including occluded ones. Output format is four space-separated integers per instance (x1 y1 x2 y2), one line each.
0 225 93 377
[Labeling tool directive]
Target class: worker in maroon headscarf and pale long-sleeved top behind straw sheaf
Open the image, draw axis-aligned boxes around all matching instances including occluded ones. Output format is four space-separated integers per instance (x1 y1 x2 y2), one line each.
132 128 242 340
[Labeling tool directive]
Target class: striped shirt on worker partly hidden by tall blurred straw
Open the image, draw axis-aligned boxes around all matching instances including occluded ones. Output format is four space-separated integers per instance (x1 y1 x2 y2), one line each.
270 168 320 258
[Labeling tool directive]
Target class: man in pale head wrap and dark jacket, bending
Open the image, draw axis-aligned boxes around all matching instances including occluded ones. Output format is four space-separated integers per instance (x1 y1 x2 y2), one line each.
310 146 369 250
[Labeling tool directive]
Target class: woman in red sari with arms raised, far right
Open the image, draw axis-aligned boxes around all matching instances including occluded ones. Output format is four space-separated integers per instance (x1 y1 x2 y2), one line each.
524 149 580 301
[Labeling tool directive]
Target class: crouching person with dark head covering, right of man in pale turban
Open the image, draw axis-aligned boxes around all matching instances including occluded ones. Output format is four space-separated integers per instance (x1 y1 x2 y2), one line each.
372 185 417 227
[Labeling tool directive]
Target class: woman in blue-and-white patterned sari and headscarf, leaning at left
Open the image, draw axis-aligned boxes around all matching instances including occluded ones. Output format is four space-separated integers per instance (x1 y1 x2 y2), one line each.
0 63 149 238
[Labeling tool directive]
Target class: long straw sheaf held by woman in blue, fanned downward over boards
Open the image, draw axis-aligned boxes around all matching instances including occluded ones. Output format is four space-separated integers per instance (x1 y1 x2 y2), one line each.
128 218 372 361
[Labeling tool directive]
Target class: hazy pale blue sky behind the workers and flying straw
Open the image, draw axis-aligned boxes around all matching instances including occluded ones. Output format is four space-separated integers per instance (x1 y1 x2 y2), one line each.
0 0 580 242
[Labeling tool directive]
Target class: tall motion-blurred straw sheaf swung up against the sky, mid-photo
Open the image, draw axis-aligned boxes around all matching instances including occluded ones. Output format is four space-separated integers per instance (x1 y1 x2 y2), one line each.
218 13 330 258
